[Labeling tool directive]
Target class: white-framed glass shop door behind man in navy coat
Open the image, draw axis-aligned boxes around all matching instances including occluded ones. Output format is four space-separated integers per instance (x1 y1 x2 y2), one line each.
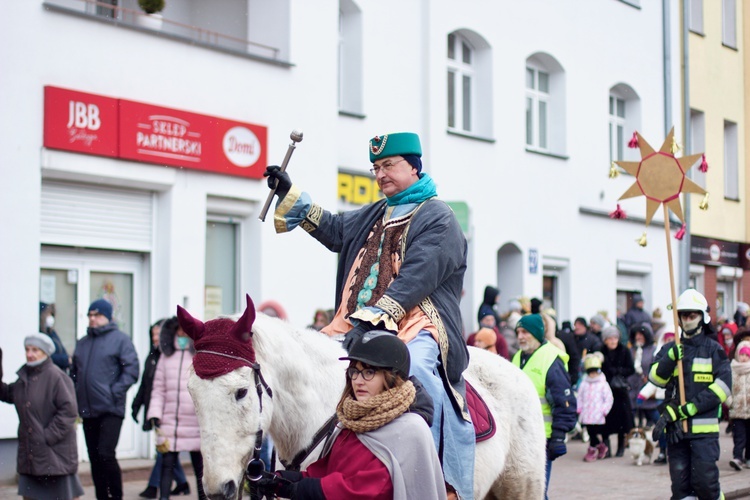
39 247 149 460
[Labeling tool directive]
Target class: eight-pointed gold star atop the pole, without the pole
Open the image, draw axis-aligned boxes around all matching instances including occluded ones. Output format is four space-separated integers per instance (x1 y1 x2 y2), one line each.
615 128 707 226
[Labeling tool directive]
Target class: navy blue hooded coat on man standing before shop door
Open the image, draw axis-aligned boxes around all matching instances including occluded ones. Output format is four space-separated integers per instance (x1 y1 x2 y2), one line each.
70 323 139 418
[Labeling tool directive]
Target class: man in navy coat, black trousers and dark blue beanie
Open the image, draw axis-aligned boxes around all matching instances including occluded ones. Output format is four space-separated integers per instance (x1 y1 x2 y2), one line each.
70 299 138 499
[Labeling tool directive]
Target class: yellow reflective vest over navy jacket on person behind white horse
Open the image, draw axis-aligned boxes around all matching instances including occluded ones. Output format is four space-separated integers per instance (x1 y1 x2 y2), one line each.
513 342 578 439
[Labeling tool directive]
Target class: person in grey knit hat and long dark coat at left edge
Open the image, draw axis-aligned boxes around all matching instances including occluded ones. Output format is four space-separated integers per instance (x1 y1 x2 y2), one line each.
0 333 83 500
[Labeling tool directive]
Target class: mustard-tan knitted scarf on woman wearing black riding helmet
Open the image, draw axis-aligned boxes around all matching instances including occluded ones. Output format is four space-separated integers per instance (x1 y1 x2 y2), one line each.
336 381 417 433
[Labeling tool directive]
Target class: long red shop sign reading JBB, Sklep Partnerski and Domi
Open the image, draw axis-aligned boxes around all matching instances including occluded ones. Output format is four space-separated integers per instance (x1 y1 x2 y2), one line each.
44 86 268 179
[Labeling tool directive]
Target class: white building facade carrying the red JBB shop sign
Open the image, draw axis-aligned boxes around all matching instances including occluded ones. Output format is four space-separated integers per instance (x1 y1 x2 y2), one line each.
0 0 692 478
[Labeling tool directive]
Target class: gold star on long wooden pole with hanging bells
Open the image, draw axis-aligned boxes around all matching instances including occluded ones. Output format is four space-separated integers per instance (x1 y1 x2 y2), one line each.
610 127 708 432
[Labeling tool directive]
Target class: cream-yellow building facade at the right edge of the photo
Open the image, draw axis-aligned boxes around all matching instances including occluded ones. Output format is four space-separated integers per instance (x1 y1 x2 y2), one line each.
685 0 750 320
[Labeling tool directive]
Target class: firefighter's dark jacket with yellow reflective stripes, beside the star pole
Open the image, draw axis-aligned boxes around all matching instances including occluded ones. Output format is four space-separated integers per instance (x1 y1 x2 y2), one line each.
648 333 732 437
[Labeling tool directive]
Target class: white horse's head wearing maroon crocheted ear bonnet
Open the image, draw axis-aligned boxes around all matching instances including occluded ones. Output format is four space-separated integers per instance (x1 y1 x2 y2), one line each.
177 296 272 500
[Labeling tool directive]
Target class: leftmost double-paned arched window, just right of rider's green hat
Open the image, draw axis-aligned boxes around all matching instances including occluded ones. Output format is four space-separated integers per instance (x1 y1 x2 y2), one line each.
446 30 492 138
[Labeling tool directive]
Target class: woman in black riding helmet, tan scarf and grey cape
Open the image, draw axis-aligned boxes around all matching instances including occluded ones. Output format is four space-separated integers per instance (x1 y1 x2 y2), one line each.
258 331 446 500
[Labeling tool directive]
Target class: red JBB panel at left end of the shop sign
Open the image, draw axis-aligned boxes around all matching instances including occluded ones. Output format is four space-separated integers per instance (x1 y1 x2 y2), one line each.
44 87 118 157
